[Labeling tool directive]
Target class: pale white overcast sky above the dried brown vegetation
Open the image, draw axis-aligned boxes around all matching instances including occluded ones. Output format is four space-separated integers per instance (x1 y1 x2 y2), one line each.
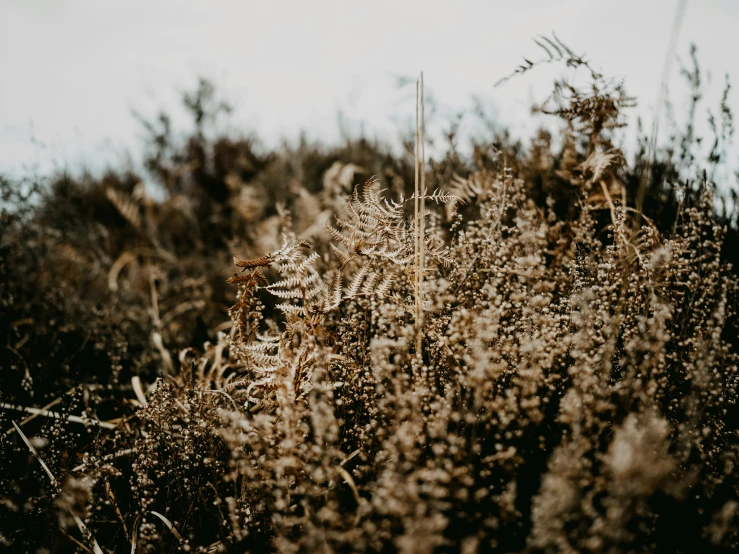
0 0 739 179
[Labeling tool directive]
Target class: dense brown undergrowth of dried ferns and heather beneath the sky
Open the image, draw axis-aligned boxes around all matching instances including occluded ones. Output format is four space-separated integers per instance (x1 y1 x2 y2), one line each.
0 41 739 553
